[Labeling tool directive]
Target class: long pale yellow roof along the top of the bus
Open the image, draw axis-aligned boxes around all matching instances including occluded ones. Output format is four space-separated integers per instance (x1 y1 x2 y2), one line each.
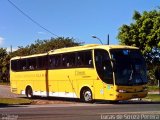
11 44 138 60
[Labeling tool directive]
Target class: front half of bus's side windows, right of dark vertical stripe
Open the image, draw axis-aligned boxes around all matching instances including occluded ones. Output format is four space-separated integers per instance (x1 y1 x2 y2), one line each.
49 50 93 69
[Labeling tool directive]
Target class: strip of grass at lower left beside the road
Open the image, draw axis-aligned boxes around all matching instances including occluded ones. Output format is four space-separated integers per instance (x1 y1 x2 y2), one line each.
0 98 32 105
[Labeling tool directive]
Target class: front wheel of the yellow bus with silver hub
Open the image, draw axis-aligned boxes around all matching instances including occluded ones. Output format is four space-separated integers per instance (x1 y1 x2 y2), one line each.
82 88 93 103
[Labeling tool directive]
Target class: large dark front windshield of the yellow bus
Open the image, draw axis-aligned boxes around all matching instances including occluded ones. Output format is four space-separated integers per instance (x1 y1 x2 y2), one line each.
110 49 147 86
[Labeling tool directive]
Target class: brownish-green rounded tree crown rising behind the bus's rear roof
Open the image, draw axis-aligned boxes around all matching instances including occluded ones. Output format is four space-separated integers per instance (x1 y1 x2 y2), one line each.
12 37 81 56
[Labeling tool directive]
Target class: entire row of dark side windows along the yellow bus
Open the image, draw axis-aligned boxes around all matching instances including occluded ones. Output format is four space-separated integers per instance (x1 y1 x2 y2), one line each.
11 50 93 71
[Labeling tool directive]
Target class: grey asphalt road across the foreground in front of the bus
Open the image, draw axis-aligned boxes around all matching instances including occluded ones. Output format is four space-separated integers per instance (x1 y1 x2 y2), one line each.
0 103 160 120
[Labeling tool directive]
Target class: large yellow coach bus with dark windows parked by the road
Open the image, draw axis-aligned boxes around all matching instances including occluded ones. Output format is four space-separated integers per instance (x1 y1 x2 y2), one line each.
10 44 148 102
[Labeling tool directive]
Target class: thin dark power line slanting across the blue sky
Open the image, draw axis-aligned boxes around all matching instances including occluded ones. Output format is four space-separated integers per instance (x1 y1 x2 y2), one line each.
8 0 59 37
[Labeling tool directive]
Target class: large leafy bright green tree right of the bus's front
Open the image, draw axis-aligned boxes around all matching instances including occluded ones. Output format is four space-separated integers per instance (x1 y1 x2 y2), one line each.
117 10 160 85
